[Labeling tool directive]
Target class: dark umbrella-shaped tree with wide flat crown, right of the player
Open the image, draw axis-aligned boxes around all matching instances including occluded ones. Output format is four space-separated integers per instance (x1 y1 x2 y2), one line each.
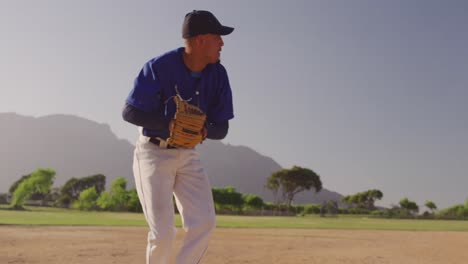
266 166 322 207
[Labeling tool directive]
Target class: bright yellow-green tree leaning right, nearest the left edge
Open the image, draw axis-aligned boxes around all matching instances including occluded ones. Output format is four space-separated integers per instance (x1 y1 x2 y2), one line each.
10 168 55 209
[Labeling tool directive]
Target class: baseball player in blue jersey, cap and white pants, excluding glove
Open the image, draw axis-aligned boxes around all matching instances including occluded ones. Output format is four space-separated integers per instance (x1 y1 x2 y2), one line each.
122 10 234 264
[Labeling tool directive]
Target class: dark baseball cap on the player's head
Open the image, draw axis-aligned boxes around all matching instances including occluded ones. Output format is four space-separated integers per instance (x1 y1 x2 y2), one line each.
182 10 234 39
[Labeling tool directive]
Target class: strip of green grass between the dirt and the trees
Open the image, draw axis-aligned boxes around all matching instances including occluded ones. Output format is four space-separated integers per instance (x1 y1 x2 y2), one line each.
0 206 468 231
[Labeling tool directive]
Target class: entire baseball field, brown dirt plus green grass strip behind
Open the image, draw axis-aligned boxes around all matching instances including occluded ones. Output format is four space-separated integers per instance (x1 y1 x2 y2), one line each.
0 208 468 264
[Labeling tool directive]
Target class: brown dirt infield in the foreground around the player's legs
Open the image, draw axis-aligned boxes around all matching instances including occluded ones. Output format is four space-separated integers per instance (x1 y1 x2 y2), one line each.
0 226 468 264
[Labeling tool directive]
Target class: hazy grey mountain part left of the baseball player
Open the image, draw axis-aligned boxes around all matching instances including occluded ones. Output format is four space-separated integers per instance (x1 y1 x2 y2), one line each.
0 113 133 192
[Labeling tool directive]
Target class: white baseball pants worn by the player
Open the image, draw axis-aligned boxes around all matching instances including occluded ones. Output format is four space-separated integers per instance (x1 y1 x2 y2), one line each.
133 136 216 264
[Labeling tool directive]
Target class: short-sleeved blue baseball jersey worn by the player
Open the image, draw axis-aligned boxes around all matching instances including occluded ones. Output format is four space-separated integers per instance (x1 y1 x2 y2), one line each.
126 48 234 138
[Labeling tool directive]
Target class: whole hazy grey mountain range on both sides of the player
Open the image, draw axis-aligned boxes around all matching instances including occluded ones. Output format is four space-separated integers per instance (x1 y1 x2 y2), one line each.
0 113 341 203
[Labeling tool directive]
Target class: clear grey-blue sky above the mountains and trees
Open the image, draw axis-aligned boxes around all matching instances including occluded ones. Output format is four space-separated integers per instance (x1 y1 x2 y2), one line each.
0 0 468 208
